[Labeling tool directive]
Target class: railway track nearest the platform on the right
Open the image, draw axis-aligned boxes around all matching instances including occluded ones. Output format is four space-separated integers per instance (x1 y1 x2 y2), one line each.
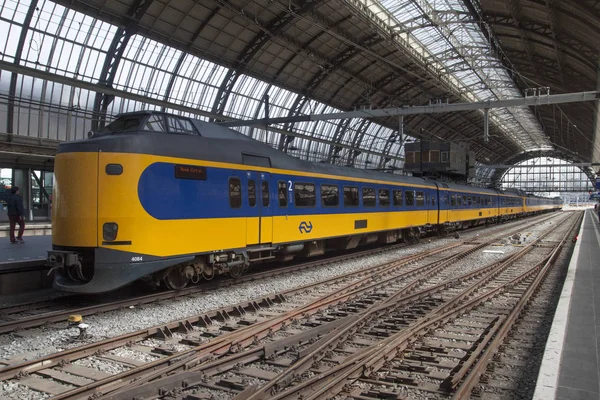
106 209 581 400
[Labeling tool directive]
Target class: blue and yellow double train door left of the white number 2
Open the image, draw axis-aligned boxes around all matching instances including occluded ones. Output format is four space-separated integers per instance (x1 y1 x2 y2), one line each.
246 171 273 245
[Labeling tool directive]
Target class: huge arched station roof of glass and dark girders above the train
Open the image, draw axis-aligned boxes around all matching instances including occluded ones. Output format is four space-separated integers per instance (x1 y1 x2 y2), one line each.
2 0 600 184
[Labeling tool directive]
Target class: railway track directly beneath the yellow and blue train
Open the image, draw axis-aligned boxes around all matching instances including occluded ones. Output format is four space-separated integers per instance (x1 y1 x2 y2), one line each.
0 215 552 334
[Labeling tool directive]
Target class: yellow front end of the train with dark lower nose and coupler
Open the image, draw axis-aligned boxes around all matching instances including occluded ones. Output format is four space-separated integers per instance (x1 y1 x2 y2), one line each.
47 112 193 294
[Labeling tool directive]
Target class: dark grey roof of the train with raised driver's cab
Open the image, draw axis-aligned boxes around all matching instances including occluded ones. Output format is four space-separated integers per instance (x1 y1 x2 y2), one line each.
76 110 552 194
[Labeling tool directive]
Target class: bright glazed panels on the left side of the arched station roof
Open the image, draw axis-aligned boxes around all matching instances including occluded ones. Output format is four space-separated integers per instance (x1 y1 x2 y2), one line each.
0 0 401 168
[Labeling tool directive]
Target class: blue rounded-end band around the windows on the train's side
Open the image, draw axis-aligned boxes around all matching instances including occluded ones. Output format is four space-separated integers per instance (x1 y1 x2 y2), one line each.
138 162 508 220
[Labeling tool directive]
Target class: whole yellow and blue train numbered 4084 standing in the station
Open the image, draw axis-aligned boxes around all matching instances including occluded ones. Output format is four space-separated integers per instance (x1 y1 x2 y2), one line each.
48 111 562 293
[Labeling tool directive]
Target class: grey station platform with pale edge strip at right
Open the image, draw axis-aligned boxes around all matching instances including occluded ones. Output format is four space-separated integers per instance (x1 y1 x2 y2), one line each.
533 209 600 400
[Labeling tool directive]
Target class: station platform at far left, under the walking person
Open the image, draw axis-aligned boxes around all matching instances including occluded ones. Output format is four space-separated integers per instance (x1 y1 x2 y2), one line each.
0 236 52 295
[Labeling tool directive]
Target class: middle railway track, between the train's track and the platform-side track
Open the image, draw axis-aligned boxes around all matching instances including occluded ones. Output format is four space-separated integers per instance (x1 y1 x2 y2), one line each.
0 211 576 399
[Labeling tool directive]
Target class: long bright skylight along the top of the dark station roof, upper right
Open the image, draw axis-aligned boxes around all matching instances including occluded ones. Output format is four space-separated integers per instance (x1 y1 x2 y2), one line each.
364 0 550 152
